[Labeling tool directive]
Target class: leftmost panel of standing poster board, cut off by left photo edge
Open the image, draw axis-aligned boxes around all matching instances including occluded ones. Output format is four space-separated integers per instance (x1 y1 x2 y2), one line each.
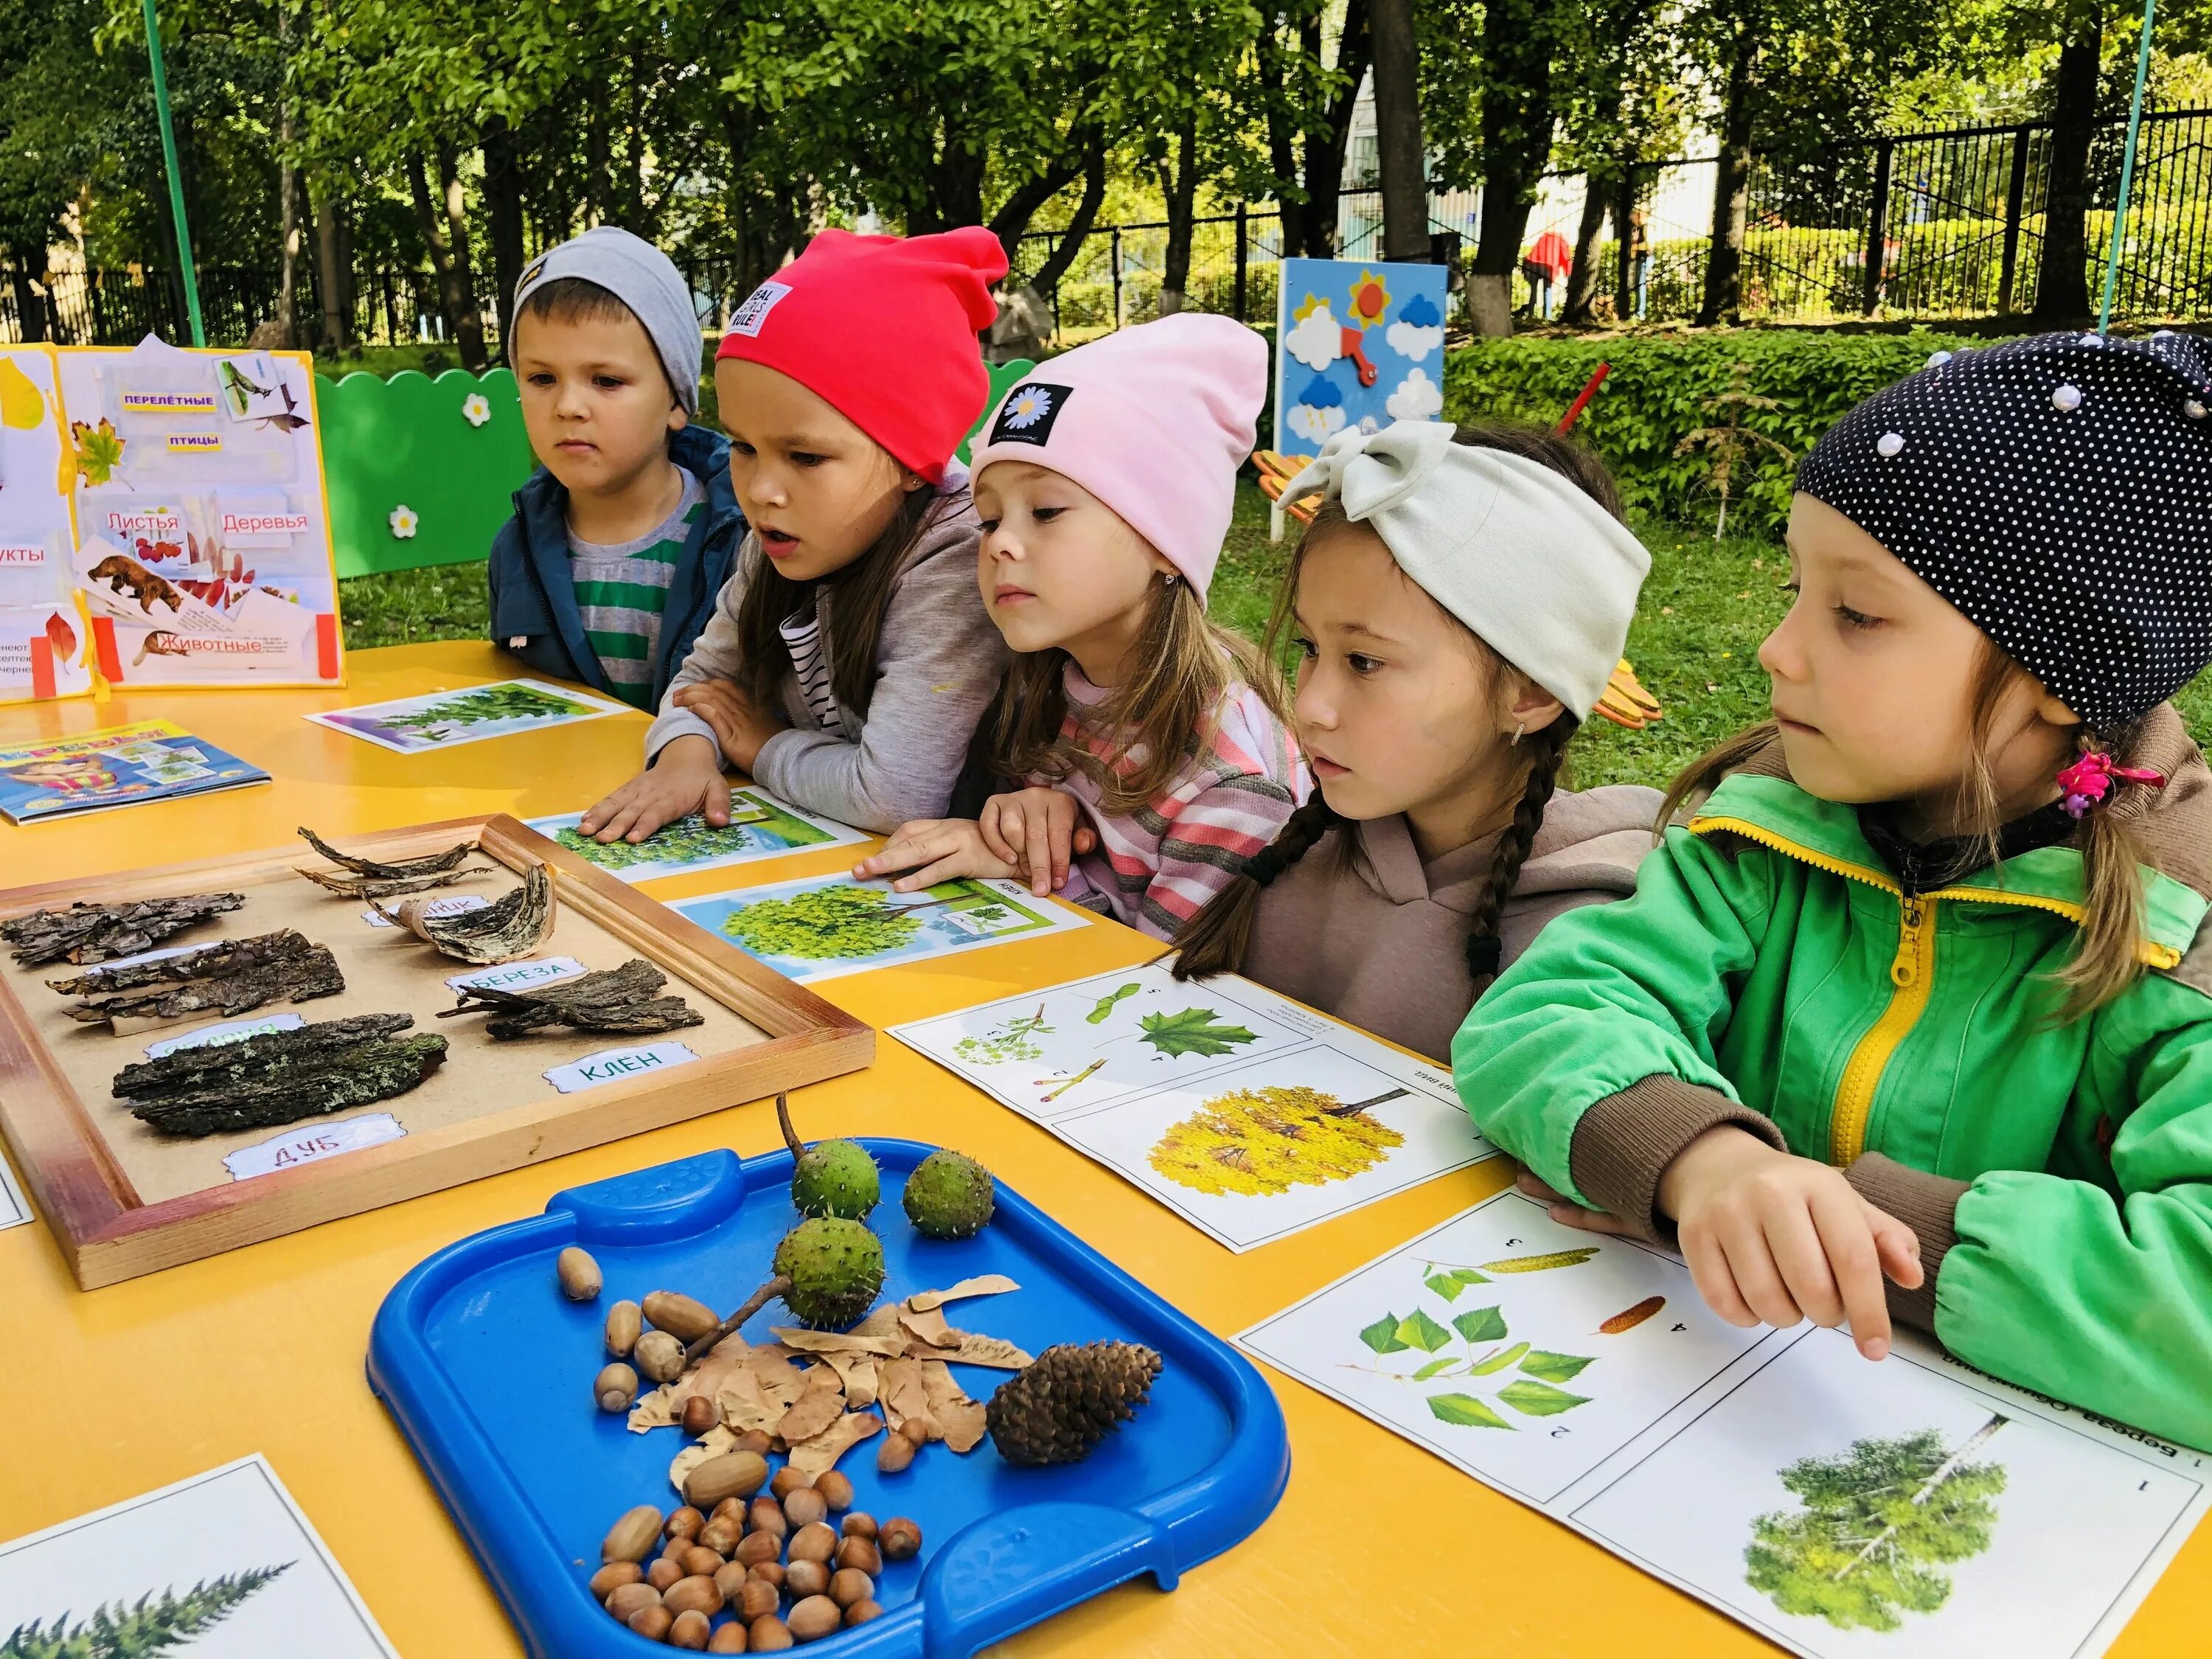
0 345 93 703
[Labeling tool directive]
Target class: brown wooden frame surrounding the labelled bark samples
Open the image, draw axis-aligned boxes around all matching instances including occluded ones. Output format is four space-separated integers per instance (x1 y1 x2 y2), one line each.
0 814 876 1290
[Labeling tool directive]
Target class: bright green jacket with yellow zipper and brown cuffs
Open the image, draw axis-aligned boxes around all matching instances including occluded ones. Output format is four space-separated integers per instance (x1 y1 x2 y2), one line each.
1453 708 2212 1447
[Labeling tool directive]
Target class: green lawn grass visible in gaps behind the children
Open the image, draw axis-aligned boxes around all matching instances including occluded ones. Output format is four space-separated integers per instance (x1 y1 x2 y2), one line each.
338 484 2212 790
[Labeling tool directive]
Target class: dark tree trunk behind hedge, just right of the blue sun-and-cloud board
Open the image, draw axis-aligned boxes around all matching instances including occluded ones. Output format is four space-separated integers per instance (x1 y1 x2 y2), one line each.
1467 0 1557 336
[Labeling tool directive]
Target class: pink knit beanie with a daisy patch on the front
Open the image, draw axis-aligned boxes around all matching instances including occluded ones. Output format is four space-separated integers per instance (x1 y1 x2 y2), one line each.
969 312 1267 599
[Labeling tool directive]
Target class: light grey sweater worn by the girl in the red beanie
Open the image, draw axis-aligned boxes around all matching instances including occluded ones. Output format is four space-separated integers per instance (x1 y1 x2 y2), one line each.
646 462 1006 832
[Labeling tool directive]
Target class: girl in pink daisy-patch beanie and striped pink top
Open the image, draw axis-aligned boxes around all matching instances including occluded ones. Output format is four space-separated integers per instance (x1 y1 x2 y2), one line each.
856 312 1310 938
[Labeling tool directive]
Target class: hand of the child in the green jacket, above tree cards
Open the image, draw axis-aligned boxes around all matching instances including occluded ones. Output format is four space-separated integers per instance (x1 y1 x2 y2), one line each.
1659 1124 1922 1360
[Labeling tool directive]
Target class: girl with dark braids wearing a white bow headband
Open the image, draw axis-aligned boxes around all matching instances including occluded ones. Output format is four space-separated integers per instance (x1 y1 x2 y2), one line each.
1175 420 1659 1055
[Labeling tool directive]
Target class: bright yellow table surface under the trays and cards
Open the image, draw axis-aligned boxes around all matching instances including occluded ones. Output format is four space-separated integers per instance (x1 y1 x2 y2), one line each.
0 644 2212 1659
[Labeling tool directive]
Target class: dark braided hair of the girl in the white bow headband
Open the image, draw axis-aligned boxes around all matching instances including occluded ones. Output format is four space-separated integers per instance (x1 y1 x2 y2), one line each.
1172 425 1621 995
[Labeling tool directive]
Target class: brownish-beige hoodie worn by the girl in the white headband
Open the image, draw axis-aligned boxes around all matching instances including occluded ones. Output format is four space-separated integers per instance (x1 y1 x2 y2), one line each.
1243 783 1659 1060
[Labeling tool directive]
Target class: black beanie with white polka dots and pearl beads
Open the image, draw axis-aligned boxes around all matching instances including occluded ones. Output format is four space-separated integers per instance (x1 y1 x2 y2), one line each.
1796 334 2212 732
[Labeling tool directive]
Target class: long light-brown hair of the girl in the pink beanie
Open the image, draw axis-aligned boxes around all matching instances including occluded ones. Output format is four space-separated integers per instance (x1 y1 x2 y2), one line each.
987 577 1290 814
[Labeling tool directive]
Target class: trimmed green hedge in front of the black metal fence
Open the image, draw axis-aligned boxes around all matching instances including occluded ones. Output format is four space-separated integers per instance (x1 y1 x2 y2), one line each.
1444 330 1980 531
